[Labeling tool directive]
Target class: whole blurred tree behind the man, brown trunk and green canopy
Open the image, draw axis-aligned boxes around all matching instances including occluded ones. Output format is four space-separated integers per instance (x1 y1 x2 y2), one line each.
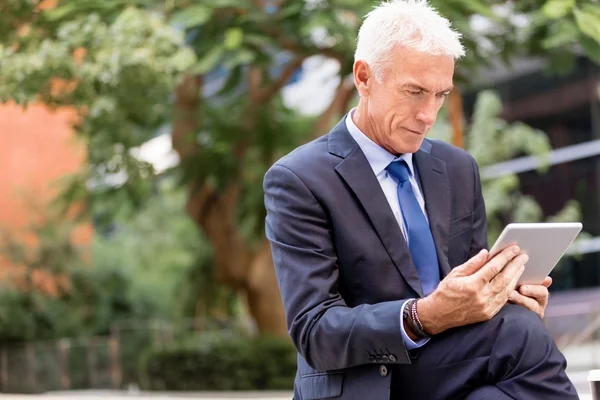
0 0 600 335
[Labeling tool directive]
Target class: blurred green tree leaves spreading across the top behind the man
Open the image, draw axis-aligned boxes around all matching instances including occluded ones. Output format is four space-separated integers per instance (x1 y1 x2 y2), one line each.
0 0 600 225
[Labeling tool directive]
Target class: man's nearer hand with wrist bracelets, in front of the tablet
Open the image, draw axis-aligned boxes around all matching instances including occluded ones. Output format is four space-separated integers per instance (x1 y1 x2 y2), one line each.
417 246 529 335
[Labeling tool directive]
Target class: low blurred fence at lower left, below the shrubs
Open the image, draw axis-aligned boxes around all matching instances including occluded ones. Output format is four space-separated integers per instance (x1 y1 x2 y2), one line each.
0 320 249 393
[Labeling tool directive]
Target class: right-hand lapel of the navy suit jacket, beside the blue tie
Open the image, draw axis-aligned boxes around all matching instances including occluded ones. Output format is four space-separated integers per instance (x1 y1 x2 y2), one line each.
413 146 450 278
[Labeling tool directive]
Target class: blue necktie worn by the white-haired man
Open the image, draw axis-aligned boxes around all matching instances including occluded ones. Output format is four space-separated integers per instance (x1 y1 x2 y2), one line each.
386 160 440 296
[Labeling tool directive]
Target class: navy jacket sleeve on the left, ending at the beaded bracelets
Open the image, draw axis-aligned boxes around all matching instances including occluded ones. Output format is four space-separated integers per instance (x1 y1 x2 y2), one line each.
264 165 410 371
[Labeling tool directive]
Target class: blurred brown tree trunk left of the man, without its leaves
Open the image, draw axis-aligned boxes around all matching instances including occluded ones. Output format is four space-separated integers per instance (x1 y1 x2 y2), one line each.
172 77 287 337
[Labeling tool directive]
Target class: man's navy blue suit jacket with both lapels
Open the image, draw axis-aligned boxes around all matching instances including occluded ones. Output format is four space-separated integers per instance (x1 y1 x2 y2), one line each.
264 117 487 400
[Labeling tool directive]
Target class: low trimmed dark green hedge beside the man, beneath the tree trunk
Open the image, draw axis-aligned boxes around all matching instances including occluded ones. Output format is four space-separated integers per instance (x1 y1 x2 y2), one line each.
141 335 296 391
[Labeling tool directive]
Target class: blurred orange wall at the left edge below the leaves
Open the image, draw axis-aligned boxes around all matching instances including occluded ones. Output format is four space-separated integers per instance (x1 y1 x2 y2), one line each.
0 104 92 292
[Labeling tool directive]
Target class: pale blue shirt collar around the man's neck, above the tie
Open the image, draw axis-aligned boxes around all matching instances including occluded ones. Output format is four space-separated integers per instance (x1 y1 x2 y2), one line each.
346 108 415 176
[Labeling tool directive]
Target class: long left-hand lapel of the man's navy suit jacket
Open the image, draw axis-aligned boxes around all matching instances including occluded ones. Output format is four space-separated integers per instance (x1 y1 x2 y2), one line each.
329 119 423 297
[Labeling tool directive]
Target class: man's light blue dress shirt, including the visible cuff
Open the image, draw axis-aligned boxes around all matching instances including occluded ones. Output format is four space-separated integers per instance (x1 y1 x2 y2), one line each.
346 108 429 350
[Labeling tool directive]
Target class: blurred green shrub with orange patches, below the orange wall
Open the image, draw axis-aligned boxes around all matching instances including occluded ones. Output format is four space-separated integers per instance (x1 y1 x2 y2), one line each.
0 211 156 343
